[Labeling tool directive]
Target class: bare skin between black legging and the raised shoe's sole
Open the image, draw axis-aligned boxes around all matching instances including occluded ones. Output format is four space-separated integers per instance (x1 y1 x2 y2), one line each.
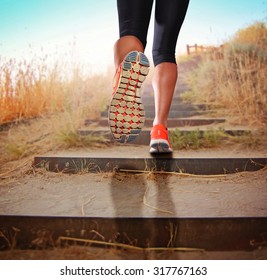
114 36 144 69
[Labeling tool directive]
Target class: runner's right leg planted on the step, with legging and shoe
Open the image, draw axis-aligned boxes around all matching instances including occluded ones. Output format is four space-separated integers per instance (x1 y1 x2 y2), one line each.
150 0 189 153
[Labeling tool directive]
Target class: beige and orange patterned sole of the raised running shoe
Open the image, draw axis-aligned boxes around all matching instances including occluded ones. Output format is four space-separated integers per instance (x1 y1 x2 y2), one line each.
108 51 149 143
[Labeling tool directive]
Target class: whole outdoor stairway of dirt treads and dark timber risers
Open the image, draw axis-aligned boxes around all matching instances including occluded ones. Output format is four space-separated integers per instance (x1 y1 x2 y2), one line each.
0 64 267 260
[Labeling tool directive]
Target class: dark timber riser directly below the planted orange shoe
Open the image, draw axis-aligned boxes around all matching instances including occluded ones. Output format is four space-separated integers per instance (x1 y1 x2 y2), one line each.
34 153 267 175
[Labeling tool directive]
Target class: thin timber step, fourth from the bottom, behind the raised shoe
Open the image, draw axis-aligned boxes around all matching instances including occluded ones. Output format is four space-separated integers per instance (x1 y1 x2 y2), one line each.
84 117 225 128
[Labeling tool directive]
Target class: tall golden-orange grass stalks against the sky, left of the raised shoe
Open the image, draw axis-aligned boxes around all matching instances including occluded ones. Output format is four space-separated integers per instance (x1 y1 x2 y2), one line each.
0 55 113 124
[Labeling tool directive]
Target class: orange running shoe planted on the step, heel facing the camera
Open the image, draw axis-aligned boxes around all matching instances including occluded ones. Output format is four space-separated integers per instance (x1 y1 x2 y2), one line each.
150 124 173 154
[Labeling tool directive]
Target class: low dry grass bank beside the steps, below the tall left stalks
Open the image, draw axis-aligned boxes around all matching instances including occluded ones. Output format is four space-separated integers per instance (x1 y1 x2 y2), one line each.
0 112 108 178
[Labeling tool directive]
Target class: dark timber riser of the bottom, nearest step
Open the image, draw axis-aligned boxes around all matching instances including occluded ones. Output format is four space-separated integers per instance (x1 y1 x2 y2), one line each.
0 215 267 250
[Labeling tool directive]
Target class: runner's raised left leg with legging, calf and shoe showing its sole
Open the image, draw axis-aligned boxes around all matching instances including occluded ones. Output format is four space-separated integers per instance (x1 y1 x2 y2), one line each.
109 0 153 143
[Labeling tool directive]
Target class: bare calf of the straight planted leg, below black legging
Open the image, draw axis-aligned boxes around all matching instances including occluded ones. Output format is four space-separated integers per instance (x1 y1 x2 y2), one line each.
152 62 178 127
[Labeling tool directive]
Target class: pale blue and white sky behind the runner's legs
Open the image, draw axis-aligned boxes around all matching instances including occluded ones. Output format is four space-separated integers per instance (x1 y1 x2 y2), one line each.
0 0 267 70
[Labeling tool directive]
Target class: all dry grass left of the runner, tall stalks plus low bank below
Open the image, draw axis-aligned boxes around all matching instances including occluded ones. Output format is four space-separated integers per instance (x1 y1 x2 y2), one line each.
0 53 113 177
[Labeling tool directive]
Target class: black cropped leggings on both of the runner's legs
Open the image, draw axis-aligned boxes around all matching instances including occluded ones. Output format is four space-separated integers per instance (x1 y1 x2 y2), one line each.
117 0 189 66
